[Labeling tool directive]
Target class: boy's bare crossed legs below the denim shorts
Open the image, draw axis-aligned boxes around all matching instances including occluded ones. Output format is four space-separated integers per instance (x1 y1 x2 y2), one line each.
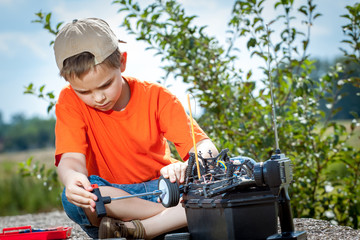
85 186 187 238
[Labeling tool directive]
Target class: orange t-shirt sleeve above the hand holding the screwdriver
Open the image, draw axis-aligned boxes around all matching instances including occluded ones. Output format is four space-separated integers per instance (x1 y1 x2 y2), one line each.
55 89 88 166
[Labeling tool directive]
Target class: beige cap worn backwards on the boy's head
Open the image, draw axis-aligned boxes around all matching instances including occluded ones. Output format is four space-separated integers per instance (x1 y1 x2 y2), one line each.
54 18 123 71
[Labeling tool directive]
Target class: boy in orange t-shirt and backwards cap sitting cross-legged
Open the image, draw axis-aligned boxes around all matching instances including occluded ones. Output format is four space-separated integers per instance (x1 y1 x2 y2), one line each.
54 18 217 239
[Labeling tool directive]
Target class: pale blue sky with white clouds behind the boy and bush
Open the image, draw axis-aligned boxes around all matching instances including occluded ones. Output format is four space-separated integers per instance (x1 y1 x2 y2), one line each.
0 0 356 121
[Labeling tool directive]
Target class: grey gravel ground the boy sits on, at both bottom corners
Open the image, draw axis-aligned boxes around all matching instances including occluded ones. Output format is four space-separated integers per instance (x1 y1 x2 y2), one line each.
0 211 360 240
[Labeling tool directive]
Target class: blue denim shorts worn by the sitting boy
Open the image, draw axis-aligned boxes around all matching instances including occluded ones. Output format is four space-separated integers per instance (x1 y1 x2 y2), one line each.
61 175 158 238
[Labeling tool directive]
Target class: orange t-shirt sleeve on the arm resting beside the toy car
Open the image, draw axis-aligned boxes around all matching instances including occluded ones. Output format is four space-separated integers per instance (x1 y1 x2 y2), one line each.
159 89 208 160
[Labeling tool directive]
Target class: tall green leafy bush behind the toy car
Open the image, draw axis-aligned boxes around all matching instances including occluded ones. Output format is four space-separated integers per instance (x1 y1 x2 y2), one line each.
30 0 360 228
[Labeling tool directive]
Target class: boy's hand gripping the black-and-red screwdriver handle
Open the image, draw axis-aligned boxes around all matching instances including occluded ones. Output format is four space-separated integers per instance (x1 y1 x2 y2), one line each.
65 171 97 212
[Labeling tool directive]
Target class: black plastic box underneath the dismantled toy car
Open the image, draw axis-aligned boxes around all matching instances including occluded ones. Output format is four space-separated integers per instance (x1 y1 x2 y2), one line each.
183 189 278 240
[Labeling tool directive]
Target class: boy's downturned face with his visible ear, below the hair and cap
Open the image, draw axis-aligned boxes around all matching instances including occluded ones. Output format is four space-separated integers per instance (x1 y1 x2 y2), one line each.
67 53 127 111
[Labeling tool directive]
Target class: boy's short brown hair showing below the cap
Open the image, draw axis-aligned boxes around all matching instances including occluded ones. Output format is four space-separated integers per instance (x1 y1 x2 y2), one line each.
60 48 121 80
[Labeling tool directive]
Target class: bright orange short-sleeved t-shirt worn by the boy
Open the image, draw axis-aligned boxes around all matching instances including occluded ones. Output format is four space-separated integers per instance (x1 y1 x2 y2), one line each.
55 77 207 184
